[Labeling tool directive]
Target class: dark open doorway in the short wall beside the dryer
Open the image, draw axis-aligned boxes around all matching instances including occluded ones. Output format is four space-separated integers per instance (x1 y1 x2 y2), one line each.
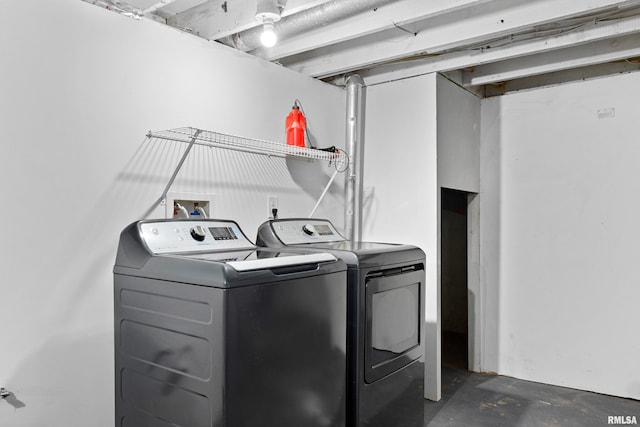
440 188 469 369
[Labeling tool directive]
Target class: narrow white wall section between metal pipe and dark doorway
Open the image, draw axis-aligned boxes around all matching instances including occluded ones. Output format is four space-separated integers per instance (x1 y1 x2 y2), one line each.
362 74 441 400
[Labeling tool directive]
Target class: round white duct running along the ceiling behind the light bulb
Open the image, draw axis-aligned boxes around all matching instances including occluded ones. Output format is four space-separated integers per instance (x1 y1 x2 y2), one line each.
224 0 394 52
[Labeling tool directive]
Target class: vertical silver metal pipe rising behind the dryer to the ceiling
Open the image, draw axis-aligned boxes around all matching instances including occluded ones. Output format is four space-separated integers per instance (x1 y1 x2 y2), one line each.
344 74 364 241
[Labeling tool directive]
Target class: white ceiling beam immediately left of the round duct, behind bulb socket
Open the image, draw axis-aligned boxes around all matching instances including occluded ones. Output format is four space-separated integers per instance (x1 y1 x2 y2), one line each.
167 0 331 40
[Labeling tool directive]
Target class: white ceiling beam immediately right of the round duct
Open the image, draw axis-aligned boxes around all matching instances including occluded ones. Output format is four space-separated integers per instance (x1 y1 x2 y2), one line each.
252 0 491 61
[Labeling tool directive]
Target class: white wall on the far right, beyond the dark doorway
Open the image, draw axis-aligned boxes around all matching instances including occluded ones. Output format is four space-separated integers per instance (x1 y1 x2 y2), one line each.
481 73 640 399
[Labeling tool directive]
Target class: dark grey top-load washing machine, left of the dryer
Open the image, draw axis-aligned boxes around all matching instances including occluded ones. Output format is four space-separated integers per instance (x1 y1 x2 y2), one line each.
114 219 347 427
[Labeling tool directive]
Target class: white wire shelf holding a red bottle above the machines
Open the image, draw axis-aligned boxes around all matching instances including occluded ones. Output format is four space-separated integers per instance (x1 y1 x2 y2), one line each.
147 127 348 163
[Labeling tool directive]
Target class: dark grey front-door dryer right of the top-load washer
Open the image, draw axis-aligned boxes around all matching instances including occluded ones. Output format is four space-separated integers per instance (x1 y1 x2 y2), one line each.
256 218 425 427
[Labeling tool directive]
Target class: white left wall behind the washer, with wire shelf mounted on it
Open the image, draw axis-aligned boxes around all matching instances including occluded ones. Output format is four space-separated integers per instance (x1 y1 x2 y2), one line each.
0 0 345 427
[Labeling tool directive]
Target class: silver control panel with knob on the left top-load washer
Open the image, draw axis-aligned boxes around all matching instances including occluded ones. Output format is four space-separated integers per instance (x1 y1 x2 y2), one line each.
139 219 255 254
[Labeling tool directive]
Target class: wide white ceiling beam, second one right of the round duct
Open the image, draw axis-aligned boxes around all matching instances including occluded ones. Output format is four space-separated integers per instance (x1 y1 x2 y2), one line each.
280 0 638 78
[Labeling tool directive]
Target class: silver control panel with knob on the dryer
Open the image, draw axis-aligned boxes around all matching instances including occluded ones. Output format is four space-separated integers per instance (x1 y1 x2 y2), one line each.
271 218 346 245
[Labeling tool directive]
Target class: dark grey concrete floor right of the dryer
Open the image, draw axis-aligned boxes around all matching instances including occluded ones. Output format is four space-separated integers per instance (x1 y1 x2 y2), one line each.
424 366 640 427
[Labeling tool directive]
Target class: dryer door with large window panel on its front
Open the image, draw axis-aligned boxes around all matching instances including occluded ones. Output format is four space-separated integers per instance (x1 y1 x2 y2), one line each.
365 265 424 383
